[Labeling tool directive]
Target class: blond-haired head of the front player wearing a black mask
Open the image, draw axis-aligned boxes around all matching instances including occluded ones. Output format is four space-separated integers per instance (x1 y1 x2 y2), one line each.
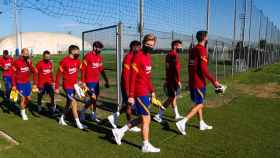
142 33 157 53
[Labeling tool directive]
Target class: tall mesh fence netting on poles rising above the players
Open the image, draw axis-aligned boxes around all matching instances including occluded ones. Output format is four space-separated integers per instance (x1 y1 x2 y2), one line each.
2 0 280 78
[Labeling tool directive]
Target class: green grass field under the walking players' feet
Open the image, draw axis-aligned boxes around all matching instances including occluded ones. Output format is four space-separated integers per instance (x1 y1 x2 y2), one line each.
0 55 280 158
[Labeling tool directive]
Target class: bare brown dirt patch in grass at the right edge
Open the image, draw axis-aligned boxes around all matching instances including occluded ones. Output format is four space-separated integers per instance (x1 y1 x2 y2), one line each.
236 83 280 99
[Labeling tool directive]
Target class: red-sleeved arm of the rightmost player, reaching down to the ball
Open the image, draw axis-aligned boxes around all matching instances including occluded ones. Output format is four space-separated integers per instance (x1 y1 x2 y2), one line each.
200 49 219 87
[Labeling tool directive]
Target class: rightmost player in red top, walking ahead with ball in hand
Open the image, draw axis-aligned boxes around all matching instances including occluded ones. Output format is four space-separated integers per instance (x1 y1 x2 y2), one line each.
176 31 224 135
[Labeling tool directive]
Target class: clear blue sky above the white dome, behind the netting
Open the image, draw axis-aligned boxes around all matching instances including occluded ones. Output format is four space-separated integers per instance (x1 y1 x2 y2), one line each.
0 0 280 38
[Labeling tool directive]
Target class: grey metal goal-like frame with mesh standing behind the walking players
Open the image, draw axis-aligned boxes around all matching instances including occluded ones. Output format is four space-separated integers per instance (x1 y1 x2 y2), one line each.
82 22 124 111
